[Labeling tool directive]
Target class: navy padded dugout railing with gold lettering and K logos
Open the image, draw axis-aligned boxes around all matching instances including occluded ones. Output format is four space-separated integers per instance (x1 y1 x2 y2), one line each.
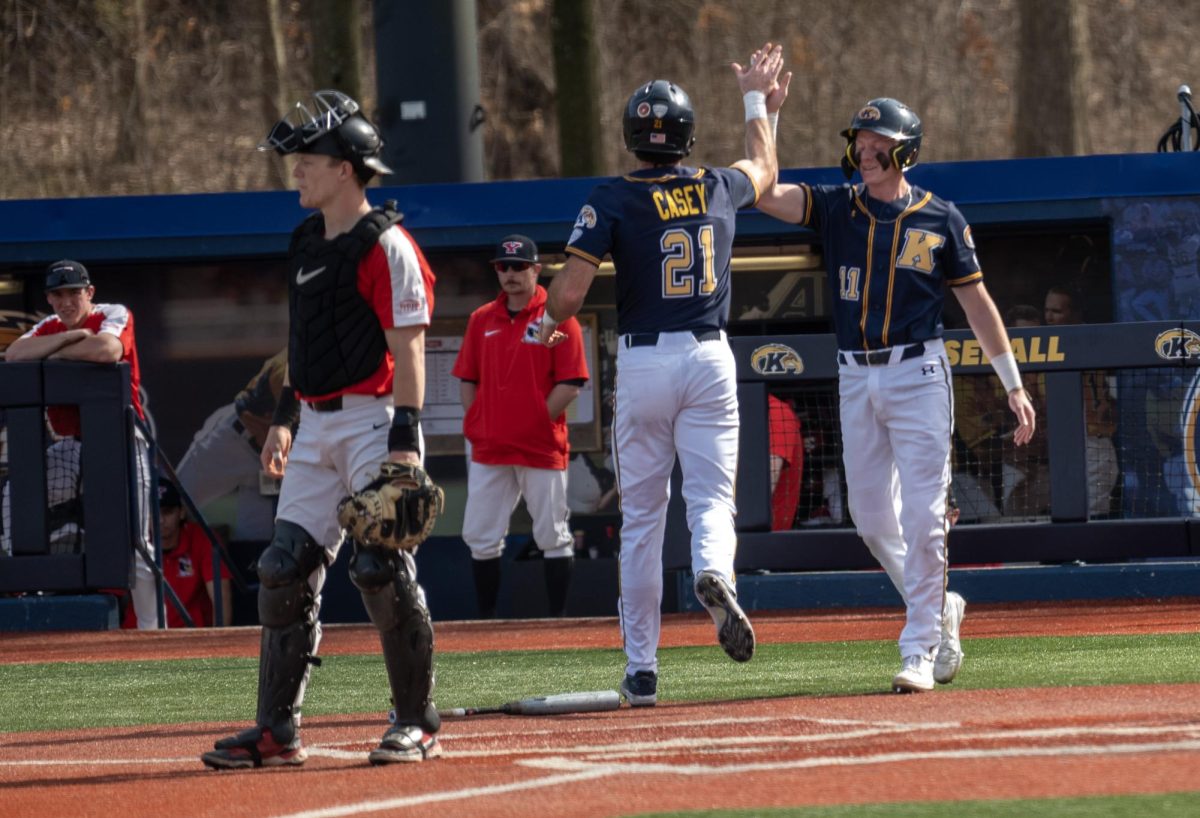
664 321 1200 572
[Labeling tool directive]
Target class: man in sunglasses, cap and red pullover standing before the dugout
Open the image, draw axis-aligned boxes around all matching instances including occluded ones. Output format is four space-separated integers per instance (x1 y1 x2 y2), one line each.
452 235 588 619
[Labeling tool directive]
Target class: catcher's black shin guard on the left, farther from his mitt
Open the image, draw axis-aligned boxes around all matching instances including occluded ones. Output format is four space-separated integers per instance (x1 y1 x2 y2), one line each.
257 519 325 745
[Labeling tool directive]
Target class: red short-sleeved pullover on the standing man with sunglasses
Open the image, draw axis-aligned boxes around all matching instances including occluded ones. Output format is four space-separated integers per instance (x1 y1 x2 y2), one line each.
451 285 588 469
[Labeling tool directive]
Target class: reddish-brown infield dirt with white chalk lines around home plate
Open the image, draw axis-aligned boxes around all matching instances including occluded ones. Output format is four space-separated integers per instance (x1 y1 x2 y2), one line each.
0 592 1200 818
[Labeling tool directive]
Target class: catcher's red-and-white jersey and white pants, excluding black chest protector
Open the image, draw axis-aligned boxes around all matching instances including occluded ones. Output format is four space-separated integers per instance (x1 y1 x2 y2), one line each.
276 225 434 554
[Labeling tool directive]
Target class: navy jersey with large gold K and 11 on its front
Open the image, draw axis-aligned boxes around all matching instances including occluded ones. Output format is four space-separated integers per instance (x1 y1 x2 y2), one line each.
802 185 983 349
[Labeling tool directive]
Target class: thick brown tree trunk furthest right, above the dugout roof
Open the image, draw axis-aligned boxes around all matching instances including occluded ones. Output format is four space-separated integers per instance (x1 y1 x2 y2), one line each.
1017 0 1091 157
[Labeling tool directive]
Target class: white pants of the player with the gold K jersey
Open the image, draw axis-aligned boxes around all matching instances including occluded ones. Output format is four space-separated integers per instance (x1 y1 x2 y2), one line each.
839 342 953 656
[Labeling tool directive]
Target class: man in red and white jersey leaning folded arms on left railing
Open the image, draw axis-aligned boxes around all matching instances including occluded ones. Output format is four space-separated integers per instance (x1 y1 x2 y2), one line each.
4 259 158 628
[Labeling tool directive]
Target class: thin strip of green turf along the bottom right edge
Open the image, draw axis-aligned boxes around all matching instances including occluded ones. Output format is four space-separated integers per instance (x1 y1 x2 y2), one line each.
641 792 1200 818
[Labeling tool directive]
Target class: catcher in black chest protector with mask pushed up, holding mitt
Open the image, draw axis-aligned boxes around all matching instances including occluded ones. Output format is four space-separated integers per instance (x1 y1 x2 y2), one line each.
200 91 442 769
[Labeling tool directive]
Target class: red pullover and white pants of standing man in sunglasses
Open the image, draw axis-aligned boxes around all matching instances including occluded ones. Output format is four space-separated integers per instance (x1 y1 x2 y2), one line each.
451 285 588 559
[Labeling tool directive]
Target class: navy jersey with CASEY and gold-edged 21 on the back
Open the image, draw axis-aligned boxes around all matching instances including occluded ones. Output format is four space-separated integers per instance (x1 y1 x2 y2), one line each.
566 166 758 333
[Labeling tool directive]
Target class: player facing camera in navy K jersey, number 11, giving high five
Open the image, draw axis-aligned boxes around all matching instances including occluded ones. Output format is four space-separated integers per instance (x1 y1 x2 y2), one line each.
758 94 1034 692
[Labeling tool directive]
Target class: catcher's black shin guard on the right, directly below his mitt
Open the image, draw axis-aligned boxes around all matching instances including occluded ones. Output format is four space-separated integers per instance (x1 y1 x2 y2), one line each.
350 543 442 733
